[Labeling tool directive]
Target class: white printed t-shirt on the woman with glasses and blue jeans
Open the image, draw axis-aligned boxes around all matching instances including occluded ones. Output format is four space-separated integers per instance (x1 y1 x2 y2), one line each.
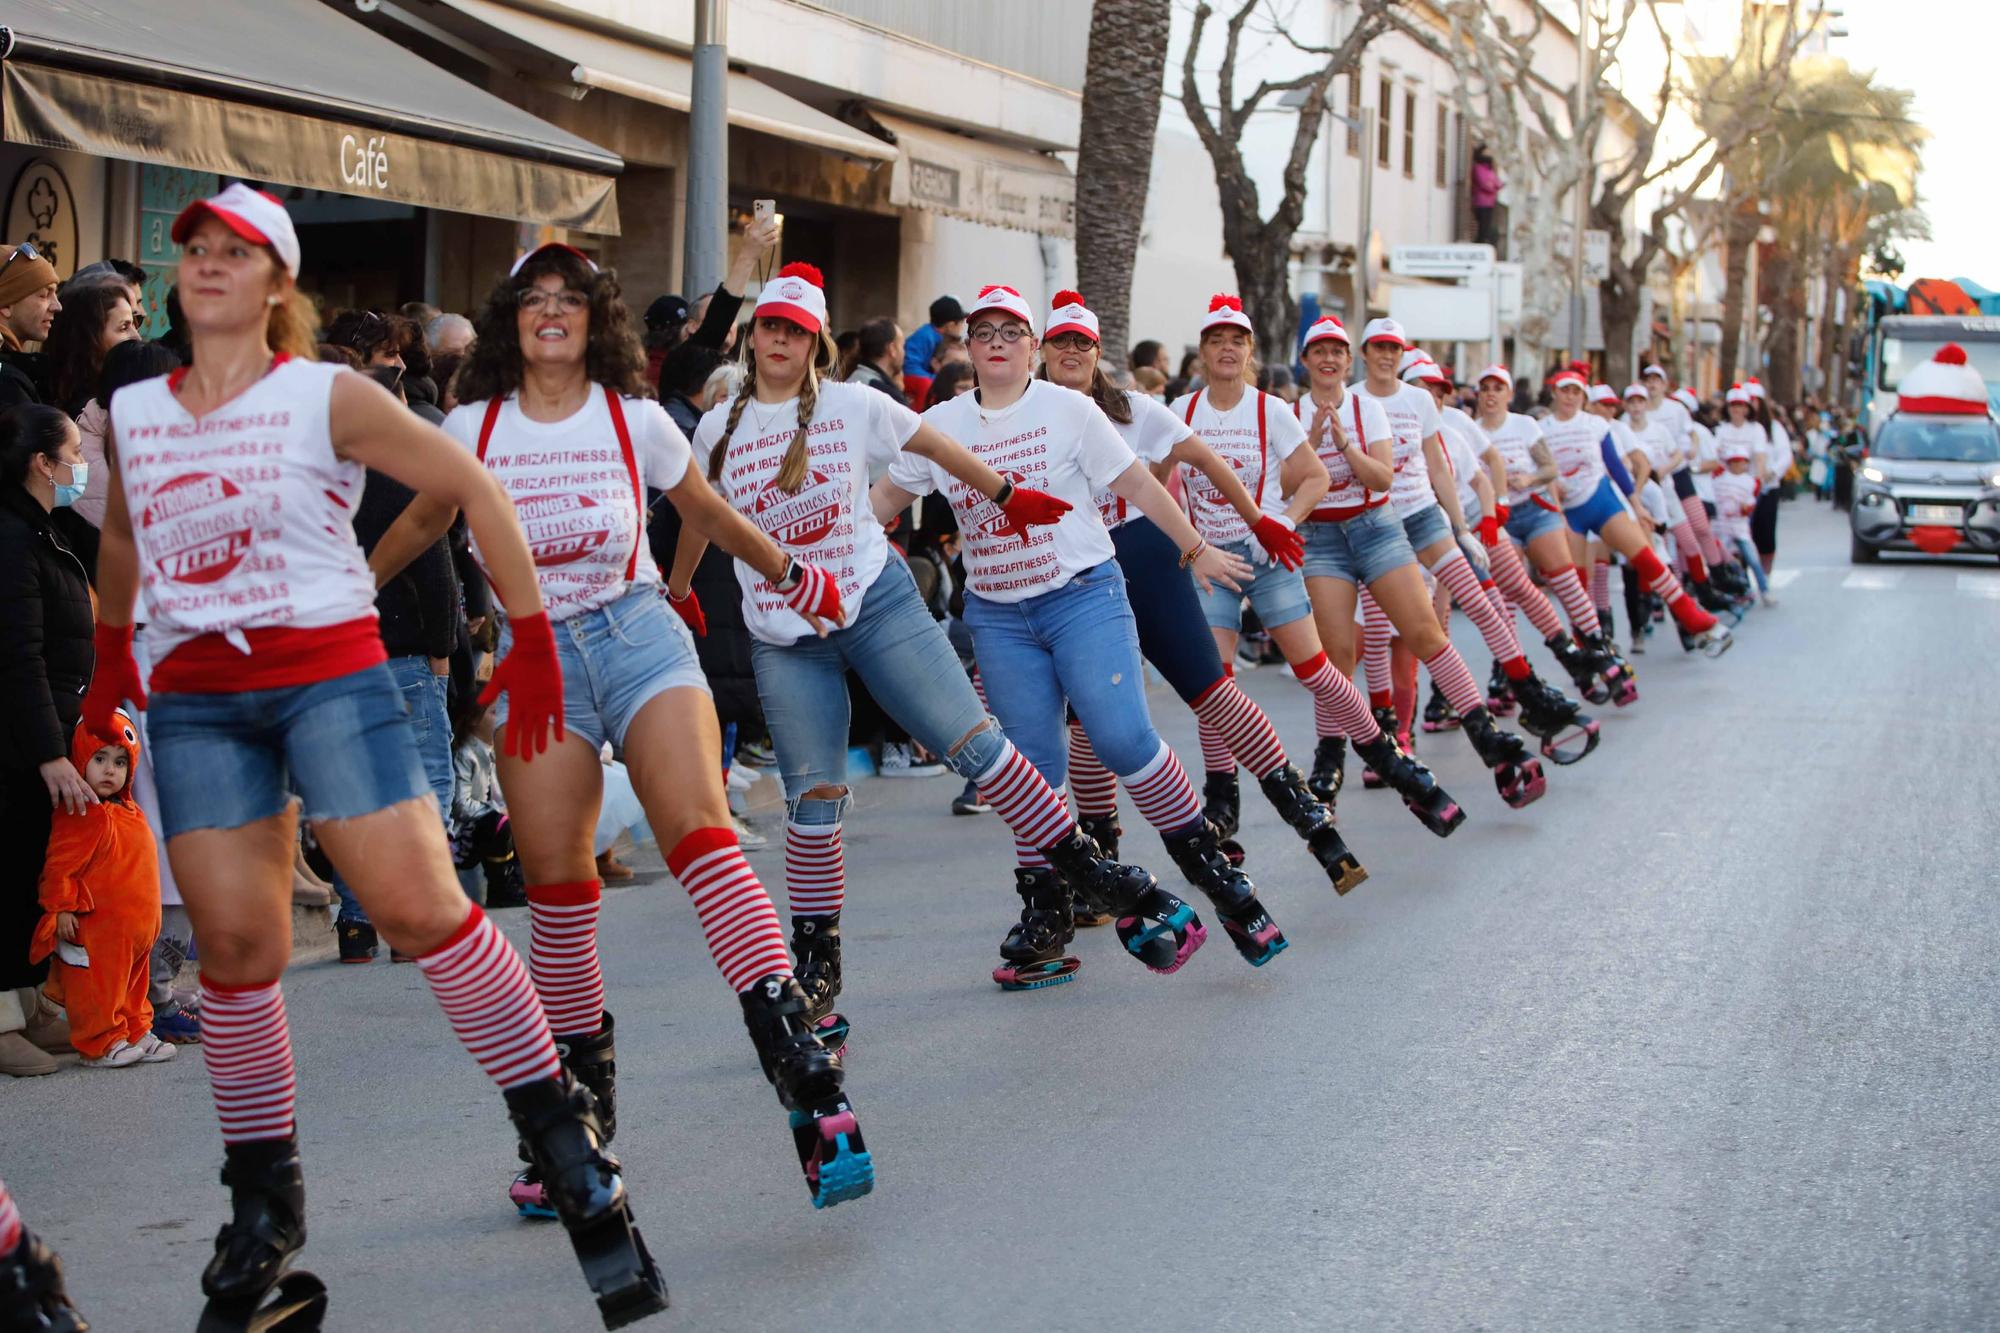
888 380 1136 602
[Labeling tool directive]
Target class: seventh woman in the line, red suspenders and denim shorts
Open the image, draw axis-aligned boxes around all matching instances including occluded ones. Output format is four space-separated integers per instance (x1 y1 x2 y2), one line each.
1292 316 1466 824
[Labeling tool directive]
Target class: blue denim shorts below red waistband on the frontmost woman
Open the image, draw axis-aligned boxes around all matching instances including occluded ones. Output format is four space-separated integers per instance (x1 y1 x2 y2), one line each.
146 664 430 839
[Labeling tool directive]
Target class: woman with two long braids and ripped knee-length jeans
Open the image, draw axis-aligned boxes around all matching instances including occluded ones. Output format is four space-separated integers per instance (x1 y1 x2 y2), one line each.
670 264 1152 1000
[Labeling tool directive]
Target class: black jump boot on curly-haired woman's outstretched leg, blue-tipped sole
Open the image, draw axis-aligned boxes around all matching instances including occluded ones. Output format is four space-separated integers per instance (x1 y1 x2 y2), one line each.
738 973 874 1209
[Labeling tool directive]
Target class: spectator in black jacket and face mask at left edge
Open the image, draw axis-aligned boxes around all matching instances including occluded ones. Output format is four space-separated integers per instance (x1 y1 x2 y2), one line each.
0 402 98 1077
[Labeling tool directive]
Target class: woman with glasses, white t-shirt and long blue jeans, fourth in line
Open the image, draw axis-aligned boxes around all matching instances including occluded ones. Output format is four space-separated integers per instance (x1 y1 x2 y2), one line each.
874 286 1284 971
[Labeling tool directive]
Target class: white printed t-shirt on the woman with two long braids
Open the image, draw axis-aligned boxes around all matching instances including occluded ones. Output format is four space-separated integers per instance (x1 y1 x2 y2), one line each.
694 382 924 646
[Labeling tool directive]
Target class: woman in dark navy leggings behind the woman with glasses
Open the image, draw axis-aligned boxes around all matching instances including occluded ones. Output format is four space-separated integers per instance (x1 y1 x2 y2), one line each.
1040 292 1368 893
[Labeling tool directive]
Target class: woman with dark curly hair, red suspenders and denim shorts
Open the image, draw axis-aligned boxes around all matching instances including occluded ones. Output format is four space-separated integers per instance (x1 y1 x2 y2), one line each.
372 244 874 1217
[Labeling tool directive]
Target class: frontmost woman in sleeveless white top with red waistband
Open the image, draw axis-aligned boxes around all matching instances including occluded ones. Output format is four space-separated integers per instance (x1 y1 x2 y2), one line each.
84 184 666 1325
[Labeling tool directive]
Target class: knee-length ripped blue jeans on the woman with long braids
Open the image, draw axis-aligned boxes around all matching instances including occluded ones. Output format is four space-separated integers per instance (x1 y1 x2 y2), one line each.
750 554 1008 825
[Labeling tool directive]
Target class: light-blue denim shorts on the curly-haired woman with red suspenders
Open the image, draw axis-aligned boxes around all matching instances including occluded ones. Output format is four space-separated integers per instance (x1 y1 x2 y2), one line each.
494 582 708 747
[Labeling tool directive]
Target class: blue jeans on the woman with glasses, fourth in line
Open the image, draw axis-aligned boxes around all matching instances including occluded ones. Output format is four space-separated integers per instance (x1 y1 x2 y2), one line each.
966 560 1168 787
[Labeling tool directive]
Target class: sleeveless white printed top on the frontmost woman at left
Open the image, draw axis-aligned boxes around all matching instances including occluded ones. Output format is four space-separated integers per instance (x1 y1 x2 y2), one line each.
112 358 380 664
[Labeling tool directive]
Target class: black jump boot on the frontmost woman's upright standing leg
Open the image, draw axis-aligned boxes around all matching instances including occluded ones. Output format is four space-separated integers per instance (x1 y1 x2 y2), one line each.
196 1135 326 1333
